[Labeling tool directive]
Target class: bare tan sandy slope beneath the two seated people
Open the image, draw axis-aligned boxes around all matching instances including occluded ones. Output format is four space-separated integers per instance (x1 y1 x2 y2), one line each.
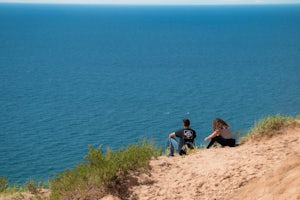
125 128 300 200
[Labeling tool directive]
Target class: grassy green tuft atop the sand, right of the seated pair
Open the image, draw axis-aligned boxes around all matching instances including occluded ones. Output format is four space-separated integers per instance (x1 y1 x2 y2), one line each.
240 114 299 144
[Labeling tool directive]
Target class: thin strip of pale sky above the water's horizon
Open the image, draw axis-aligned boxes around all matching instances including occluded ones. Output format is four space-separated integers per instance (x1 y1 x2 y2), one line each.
0 0 300 5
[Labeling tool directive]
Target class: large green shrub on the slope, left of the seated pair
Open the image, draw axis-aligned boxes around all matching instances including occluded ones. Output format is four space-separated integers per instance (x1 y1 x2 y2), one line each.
50 140 160 199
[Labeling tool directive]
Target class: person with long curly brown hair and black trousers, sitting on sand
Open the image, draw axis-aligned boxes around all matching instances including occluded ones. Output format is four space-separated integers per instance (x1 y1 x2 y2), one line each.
204 118 235 149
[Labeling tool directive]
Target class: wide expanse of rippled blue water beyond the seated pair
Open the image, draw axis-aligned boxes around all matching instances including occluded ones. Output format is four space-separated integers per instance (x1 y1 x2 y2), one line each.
0 4 300 183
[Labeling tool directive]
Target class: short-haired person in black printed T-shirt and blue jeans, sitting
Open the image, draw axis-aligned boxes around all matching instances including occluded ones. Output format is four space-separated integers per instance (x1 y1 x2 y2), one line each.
167 119 196 156
